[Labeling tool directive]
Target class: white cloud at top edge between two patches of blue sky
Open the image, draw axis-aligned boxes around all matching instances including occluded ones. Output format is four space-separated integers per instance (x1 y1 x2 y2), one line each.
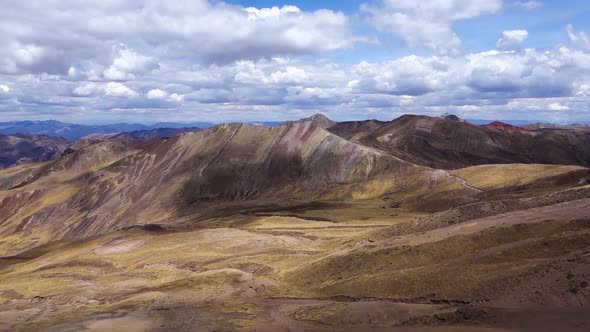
362 0 502 55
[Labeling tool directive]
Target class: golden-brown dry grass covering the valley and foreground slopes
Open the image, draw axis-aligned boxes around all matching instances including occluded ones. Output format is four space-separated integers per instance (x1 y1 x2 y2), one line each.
0 161 590 330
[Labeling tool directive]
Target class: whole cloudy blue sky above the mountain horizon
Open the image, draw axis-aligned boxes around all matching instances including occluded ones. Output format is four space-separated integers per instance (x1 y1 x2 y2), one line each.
0 0 590 123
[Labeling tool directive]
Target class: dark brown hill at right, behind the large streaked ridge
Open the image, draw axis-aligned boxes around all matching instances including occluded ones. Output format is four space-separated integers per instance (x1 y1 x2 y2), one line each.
329 115 590 169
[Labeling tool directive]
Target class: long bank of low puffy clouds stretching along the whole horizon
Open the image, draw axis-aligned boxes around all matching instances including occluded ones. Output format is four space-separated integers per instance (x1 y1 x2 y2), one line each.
0 40 590 121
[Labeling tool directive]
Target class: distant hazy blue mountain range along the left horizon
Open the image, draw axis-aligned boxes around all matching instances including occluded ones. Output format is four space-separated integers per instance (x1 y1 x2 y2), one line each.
0 120 214 140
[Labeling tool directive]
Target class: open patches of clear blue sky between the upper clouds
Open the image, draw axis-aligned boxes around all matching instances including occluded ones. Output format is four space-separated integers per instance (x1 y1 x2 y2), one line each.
227 0 590 62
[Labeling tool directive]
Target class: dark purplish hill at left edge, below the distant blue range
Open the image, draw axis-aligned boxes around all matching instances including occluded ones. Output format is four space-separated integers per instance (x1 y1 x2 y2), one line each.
0 134 69 169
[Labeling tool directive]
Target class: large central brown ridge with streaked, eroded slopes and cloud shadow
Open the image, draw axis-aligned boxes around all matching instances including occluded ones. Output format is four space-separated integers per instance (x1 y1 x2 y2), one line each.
0 121 473 254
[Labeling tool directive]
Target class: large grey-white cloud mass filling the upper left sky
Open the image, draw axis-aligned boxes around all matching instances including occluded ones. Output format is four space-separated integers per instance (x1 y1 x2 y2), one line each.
0 0 360 75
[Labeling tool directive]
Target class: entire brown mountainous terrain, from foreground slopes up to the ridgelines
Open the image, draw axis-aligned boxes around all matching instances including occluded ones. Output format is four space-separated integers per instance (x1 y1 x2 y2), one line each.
0 115 590 331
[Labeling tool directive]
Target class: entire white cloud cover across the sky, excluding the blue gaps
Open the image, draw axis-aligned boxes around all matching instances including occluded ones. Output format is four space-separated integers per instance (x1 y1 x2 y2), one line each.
0 0 590 121
